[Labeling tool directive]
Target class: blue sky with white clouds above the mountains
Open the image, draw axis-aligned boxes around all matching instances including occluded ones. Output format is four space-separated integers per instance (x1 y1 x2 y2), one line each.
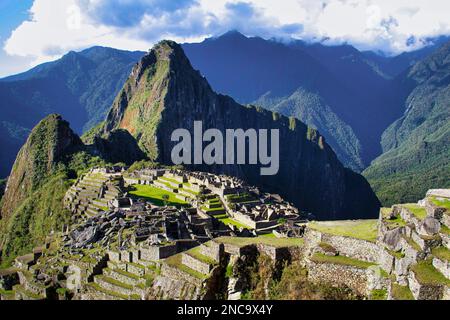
0 0 450 77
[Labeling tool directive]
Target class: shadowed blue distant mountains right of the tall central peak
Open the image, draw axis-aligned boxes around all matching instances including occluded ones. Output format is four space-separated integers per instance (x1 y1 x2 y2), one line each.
183 31 450 171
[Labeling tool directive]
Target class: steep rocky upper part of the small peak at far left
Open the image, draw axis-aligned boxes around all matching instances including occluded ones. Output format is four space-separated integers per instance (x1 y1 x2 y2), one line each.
1 114 82 218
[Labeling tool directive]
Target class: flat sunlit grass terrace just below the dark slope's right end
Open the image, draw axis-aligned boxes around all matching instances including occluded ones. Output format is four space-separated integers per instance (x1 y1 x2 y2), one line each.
308 220 378 242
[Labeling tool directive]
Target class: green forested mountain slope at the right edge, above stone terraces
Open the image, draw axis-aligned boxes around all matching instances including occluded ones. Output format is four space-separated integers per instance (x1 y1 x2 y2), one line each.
364 43 450 206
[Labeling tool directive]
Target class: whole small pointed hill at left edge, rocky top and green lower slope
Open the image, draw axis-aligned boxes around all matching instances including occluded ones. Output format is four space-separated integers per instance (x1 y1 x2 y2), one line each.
0 115 106 265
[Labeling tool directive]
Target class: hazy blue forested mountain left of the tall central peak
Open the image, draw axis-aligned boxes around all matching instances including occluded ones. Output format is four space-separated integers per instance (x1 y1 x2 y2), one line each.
0 47 144 178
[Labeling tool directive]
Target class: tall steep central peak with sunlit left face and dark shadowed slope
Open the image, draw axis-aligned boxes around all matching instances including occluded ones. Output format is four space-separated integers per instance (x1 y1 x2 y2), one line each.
103 41 379 219
